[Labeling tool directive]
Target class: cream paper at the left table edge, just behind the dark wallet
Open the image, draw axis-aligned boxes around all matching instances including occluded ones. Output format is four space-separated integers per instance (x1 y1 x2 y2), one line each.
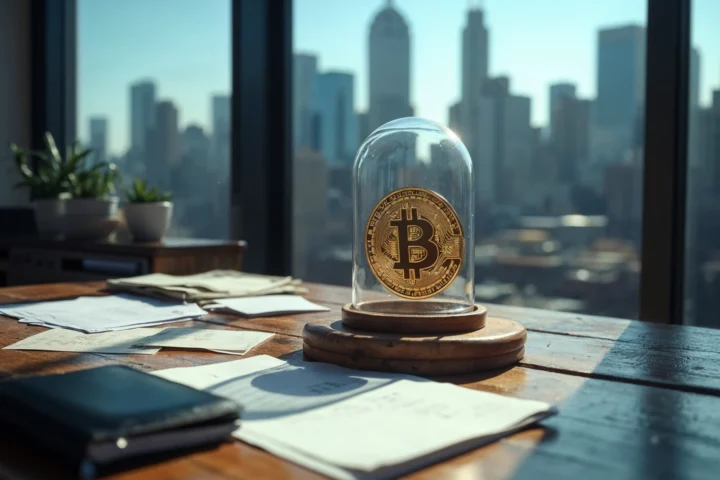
4 328 162 355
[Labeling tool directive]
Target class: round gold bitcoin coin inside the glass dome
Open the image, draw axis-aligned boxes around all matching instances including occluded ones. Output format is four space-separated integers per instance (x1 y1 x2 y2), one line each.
365 187 465 299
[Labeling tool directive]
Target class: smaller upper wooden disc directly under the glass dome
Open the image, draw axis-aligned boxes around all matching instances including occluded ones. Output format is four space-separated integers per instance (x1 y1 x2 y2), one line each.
342 302 487 335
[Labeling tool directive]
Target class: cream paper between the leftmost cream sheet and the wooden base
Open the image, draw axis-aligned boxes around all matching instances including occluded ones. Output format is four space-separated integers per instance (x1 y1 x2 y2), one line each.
136 328 273 355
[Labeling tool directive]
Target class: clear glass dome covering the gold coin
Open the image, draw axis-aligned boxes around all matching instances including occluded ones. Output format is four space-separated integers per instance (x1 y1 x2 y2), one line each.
352 117 475 315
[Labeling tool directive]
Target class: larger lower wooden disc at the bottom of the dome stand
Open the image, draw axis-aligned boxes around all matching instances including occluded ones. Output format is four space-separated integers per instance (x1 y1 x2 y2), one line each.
303 318 526 376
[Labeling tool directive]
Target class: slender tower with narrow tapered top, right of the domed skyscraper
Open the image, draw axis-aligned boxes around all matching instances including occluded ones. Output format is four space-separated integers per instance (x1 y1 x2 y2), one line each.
461 8 489 102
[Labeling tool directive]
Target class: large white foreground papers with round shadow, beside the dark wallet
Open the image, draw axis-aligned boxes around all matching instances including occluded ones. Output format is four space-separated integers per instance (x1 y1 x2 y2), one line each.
156 355 554 479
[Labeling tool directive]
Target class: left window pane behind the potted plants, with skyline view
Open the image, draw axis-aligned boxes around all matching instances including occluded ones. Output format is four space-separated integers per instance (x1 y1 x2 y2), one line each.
77 0 231 238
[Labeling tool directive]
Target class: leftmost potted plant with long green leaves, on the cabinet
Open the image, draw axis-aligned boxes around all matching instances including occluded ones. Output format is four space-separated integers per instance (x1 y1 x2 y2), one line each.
10 132 91 235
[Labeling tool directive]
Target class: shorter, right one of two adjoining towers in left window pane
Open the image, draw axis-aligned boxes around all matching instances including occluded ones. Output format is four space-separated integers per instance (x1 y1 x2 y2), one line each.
145 100 181 188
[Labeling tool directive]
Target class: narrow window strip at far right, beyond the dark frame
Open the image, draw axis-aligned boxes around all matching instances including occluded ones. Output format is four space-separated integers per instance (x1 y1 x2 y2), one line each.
685 0 720 326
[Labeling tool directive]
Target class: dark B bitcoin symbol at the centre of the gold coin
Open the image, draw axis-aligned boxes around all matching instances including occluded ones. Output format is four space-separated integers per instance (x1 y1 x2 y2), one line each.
390 208 439 279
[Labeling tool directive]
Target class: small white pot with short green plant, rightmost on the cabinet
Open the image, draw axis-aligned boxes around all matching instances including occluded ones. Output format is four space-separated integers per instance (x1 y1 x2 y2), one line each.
124 179 173 242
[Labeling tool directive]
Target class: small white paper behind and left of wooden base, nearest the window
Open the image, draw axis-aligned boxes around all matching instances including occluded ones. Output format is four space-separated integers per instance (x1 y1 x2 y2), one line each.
203 295 330 317
